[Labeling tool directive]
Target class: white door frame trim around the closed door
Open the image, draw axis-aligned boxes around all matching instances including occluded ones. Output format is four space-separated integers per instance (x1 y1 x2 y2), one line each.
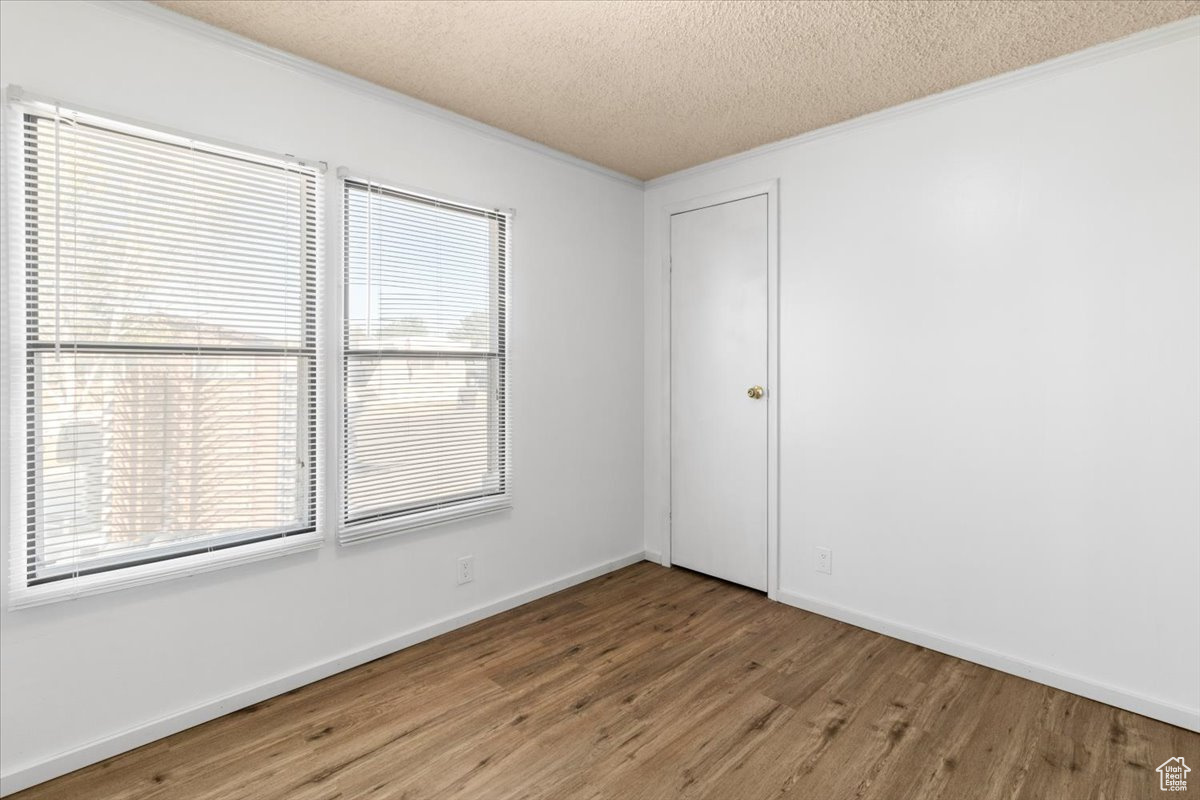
659 178 779 600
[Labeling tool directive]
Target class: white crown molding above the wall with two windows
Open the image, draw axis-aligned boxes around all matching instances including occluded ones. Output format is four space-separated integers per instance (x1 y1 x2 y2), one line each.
88 0 642 188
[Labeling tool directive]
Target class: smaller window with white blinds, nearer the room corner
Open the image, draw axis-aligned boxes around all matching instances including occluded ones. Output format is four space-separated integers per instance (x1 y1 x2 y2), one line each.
341 179 509 542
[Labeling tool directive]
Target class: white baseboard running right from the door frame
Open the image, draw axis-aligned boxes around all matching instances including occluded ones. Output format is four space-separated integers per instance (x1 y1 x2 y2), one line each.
779 589 1200 732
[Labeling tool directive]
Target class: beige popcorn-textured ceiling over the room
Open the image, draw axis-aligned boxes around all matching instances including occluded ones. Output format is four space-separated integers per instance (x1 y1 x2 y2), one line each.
158 0 1200 179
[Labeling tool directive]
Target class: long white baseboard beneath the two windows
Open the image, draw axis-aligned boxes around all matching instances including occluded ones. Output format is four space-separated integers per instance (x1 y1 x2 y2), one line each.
0 551 646 796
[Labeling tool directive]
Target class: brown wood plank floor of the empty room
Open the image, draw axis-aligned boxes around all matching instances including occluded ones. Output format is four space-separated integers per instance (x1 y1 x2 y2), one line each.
14 563 1200 800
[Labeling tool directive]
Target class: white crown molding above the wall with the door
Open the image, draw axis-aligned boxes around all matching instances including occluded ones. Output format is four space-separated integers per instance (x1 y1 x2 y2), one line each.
644 17 1200 190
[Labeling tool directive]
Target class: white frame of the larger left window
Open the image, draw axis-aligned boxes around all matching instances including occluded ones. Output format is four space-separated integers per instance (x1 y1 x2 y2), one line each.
0 86 326 609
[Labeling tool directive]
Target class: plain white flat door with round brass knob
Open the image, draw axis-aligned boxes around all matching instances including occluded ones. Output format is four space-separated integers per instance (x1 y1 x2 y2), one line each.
671 194 768 591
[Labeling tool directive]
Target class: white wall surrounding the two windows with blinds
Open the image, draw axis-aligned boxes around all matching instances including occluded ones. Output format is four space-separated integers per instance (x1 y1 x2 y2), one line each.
0 1 643 788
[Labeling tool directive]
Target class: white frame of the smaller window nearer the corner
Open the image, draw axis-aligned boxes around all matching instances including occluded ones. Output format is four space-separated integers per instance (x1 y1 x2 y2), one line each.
329 172 516 546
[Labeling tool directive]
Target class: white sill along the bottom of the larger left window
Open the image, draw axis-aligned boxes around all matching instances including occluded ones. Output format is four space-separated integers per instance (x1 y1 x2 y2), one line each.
8 533 325 610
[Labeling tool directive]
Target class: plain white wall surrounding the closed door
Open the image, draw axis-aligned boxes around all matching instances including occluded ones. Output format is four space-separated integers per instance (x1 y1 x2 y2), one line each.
644 20 1200 729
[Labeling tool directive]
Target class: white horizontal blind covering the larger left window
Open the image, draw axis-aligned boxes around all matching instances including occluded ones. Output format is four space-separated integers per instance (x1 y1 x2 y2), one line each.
10 97 320 604
